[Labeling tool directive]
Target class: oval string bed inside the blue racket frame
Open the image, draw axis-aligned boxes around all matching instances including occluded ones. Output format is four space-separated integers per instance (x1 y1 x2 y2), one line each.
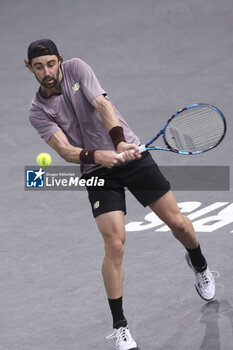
165 106 225 152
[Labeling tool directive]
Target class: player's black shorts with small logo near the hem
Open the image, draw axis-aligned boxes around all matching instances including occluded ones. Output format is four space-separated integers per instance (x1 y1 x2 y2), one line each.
82 152 170 218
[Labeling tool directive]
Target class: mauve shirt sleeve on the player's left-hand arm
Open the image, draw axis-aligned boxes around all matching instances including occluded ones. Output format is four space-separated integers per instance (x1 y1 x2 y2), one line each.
29 108 61 142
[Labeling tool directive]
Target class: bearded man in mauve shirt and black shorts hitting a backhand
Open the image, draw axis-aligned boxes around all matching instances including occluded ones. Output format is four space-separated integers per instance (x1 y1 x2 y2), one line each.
25 39 215 350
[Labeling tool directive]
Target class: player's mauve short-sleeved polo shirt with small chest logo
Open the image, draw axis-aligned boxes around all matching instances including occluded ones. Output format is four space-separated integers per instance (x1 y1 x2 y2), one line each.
29 58 140 173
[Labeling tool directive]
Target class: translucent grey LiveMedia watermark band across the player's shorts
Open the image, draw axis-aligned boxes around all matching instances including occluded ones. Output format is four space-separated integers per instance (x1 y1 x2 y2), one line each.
25 165 230 191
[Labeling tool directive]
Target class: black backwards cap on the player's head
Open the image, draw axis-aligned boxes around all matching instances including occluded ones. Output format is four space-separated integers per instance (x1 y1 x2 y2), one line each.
28 39 59 61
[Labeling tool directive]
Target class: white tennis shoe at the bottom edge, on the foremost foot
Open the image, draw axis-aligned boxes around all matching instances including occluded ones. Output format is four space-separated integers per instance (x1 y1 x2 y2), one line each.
106 326 138 350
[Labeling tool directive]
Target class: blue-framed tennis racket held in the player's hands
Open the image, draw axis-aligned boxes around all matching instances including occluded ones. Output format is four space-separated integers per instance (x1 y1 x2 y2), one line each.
121 103 227 155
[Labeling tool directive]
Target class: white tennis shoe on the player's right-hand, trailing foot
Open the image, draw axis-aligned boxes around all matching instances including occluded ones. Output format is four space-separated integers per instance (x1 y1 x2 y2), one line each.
185 253 215 301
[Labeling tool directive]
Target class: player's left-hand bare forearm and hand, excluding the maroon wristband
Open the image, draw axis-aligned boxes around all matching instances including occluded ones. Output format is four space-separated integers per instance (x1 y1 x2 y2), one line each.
47 130 123 168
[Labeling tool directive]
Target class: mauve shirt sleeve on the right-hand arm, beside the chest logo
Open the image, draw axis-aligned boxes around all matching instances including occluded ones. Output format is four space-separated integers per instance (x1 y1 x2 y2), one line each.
73 58 107 103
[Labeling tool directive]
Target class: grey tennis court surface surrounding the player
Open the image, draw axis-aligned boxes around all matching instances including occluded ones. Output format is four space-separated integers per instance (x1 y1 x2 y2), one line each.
0 0 233 350
